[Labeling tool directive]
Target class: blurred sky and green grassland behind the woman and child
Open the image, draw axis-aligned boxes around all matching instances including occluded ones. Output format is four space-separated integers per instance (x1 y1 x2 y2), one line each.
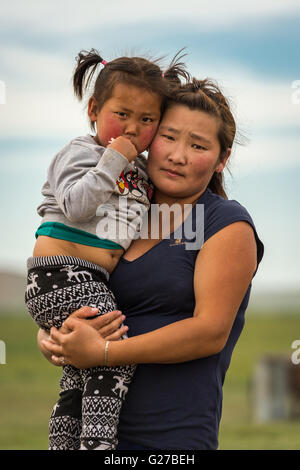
0 0 300 449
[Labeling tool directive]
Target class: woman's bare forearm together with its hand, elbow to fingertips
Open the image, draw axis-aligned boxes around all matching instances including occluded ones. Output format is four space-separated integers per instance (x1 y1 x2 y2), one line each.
45 308 230 369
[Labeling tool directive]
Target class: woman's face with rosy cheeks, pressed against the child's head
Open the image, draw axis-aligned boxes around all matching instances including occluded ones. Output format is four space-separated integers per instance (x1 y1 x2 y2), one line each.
147 105 230 203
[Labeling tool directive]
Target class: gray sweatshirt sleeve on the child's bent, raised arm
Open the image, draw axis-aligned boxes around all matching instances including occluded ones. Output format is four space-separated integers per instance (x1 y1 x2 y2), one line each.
48 143 128 222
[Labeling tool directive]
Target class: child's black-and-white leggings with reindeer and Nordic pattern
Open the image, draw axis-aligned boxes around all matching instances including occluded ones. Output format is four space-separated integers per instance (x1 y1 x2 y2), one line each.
25 255 135 450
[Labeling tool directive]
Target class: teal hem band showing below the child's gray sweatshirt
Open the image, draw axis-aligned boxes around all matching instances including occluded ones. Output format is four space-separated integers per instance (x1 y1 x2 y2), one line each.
35 222 123 250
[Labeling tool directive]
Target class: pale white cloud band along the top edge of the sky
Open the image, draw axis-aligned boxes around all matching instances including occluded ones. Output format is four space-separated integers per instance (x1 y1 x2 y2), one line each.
0 0 300 34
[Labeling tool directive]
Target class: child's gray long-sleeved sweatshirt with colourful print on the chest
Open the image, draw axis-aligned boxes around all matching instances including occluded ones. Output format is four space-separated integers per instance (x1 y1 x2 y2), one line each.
37 135 153 250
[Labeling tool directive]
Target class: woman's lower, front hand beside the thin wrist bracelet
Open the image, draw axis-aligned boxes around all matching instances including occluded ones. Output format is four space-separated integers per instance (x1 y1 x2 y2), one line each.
42 316 106 369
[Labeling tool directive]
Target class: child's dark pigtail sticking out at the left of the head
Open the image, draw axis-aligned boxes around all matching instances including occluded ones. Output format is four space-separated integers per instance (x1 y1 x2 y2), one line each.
73 49 105 100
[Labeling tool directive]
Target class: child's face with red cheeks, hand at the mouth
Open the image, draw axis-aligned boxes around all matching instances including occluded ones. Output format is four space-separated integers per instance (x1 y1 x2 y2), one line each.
88 83 162 153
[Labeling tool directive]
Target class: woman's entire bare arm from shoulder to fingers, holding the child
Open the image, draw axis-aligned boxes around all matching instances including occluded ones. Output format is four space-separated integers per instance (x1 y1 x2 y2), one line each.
42 221 257 368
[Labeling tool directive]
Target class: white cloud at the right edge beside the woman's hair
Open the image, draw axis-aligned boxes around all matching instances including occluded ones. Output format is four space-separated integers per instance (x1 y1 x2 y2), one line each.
189 61 300 132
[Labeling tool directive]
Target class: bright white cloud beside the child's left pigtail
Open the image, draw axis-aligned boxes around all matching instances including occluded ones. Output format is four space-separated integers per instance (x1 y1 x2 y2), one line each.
0 46 88 138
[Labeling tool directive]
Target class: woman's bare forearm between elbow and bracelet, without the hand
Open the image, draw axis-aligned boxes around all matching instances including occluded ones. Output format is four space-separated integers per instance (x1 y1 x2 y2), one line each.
106 317 227 366
